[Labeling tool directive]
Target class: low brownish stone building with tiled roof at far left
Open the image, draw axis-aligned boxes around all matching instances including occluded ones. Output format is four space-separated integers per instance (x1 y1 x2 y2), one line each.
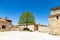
0 18 12 31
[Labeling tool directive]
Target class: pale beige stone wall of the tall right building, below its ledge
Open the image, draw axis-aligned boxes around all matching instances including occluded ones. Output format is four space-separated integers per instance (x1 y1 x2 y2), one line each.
49 17 60 34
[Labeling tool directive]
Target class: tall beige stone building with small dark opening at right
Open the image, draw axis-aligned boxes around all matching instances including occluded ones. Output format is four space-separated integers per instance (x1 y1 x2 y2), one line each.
48 6 60 34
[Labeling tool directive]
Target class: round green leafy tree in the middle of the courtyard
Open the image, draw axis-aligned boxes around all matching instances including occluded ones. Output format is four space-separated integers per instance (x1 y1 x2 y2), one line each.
18 12 35 27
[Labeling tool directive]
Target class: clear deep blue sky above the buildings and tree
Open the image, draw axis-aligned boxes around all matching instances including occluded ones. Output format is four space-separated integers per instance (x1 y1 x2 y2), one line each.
0 0 60 25
